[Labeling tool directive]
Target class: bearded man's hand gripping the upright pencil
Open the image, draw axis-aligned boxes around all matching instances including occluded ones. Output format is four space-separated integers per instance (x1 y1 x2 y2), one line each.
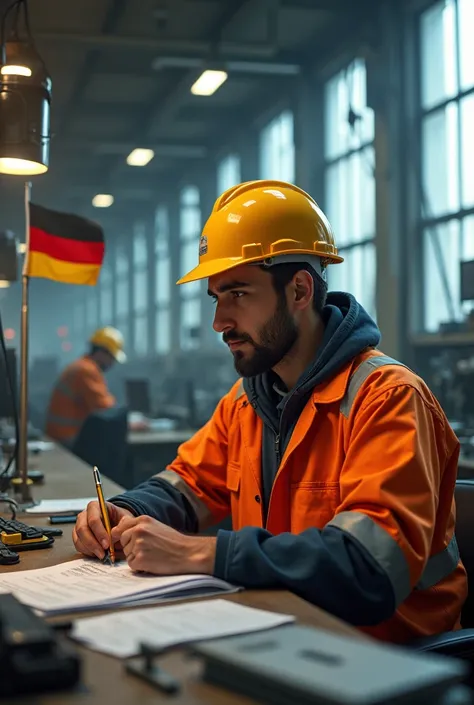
72 502 133 560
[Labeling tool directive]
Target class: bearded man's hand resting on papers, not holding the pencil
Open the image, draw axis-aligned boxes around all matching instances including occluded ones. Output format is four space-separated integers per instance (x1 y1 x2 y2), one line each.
112 516 216 575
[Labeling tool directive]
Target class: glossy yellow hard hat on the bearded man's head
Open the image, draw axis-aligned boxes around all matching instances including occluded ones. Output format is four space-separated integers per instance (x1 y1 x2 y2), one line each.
177 180 343 284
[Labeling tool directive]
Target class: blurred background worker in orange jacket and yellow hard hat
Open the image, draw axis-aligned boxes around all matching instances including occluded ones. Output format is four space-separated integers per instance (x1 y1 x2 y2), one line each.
46 326 126 448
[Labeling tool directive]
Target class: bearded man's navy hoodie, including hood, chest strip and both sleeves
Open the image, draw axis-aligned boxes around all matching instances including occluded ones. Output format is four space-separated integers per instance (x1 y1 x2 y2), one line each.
111 292 395 626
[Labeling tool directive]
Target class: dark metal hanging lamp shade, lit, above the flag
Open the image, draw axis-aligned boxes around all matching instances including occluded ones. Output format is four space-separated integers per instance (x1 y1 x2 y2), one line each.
0 41 51 176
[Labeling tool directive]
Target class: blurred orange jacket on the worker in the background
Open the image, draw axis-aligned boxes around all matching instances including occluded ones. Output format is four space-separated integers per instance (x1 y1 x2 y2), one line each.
46 356 115 445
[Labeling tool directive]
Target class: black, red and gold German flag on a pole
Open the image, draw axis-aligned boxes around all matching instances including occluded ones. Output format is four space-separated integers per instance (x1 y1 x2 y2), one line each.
25 203 105 286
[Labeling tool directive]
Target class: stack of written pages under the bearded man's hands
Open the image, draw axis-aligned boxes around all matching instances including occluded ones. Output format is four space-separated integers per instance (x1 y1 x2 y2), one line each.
0 558 239 616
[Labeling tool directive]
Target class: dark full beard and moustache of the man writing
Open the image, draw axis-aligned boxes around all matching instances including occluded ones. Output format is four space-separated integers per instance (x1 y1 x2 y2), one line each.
224 294 298 377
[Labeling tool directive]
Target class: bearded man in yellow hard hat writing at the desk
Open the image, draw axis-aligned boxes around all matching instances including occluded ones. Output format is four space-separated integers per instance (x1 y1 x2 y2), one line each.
73 181 467 643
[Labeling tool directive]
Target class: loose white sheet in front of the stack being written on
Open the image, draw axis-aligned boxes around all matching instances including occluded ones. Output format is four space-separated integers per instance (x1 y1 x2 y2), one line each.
72 600 295 658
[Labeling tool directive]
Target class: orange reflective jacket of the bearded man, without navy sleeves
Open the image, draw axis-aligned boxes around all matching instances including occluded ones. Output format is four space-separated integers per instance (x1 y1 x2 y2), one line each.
159 350 467 643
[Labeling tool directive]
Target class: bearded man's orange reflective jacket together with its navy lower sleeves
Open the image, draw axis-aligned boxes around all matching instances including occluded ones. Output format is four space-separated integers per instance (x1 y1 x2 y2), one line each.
112 350 467 643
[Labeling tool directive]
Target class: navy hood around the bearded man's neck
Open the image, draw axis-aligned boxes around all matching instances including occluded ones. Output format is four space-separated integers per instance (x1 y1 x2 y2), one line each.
244 292 380 427
